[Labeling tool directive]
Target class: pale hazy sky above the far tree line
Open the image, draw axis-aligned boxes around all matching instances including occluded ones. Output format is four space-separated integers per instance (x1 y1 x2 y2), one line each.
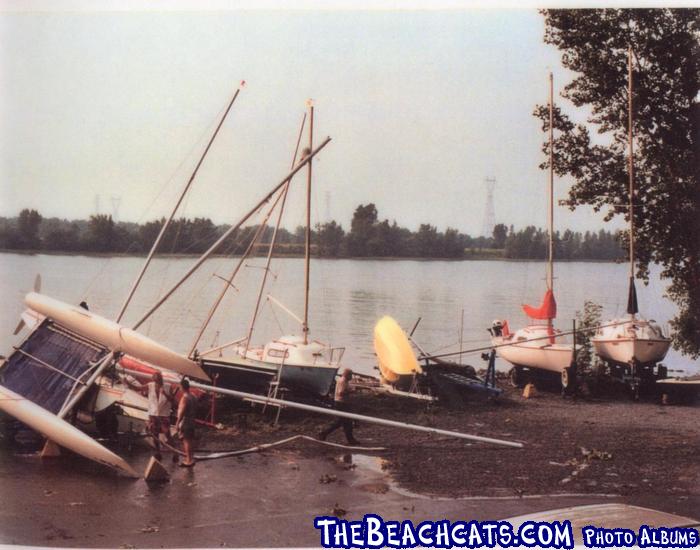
0 1 624 239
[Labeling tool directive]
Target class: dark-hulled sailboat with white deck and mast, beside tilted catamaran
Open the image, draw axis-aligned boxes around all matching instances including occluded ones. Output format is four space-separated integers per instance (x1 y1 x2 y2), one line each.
198 102 345 396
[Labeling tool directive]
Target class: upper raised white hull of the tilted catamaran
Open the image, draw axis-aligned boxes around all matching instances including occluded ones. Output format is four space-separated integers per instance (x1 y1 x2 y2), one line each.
24 292 209 380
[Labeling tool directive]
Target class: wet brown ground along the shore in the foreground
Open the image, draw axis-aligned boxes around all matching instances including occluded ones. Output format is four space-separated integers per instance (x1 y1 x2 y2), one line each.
0 392 700 548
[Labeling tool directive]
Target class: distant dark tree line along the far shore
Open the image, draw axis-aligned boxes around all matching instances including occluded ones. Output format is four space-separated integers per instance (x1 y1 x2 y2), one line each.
0 203 625 260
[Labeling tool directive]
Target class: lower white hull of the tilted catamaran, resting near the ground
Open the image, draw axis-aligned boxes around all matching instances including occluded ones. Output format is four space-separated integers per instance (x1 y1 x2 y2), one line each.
0 386 139 477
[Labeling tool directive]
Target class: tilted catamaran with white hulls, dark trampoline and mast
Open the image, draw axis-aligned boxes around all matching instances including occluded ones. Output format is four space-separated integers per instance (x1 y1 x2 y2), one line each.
0 83 247 475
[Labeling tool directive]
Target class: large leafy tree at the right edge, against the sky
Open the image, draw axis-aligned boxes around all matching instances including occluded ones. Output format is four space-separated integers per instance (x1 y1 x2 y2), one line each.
535 9 700 357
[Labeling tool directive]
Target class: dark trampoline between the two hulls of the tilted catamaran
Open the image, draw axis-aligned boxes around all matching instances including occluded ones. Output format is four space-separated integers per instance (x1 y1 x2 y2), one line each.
0 319 107 414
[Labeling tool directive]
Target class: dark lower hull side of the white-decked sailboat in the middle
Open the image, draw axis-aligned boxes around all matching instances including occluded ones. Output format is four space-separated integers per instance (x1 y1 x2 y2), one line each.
202 359 338 396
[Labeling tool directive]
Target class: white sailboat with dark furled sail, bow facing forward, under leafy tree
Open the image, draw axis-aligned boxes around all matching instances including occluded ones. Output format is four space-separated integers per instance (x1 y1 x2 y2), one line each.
591 48 671 378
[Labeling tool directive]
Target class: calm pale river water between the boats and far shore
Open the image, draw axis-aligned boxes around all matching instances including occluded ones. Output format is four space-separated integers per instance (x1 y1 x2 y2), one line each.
0 254 700 378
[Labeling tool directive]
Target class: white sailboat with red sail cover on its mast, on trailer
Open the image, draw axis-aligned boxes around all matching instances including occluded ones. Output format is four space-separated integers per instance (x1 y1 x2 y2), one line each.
491 73 574 387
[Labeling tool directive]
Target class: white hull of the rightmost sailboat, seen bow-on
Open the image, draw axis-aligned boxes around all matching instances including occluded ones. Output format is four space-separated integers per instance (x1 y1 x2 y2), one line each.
591 316 671 365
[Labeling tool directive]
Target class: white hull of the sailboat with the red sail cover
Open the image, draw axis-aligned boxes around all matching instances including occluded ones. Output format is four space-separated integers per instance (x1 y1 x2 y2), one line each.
491 325 574 374
